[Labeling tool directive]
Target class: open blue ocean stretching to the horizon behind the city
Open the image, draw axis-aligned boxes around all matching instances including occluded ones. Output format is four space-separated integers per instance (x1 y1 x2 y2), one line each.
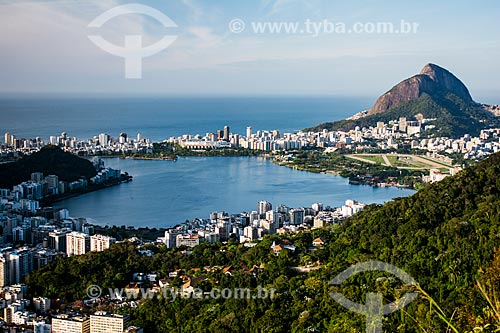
0 97 373 141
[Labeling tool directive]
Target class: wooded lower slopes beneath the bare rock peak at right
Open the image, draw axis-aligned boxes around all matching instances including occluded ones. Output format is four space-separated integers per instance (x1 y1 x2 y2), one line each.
305 93 499 137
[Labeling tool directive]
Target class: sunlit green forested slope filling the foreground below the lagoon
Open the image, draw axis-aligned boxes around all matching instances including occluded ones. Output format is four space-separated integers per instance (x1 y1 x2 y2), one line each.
28 154 500 333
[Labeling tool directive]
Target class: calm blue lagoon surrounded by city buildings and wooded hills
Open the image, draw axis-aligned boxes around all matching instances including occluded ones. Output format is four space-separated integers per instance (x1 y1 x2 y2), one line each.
56 157 413 227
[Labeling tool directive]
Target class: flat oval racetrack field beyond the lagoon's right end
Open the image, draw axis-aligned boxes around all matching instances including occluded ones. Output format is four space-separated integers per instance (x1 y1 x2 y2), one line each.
346 154 450 171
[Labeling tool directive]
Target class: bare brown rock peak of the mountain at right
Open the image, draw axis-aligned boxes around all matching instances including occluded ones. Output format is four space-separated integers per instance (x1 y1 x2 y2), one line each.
368 64 474 115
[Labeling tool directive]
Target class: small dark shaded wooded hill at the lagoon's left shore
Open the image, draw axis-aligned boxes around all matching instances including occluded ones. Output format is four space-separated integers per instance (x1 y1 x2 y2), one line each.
0 145 97 188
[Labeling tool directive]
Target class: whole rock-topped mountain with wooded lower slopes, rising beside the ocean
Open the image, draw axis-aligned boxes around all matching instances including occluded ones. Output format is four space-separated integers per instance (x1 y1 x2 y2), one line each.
305 64 499 137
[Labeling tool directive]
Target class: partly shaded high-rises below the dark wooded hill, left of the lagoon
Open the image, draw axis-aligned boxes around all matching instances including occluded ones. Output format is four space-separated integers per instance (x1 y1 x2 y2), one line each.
0 173 116 288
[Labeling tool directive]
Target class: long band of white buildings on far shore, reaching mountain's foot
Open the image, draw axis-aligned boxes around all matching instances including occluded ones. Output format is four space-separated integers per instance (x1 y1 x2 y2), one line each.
165 115 500 159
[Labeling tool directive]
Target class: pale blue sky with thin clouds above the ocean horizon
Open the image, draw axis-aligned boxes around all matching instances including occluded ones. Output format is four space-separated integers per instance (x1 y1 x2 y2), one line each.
0 0 500 100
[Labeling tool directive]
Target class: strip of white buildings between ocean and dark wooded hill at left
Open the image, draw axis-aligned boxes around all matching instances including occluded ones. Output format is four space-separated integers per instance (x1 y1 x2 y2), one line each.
0 132 153 157
